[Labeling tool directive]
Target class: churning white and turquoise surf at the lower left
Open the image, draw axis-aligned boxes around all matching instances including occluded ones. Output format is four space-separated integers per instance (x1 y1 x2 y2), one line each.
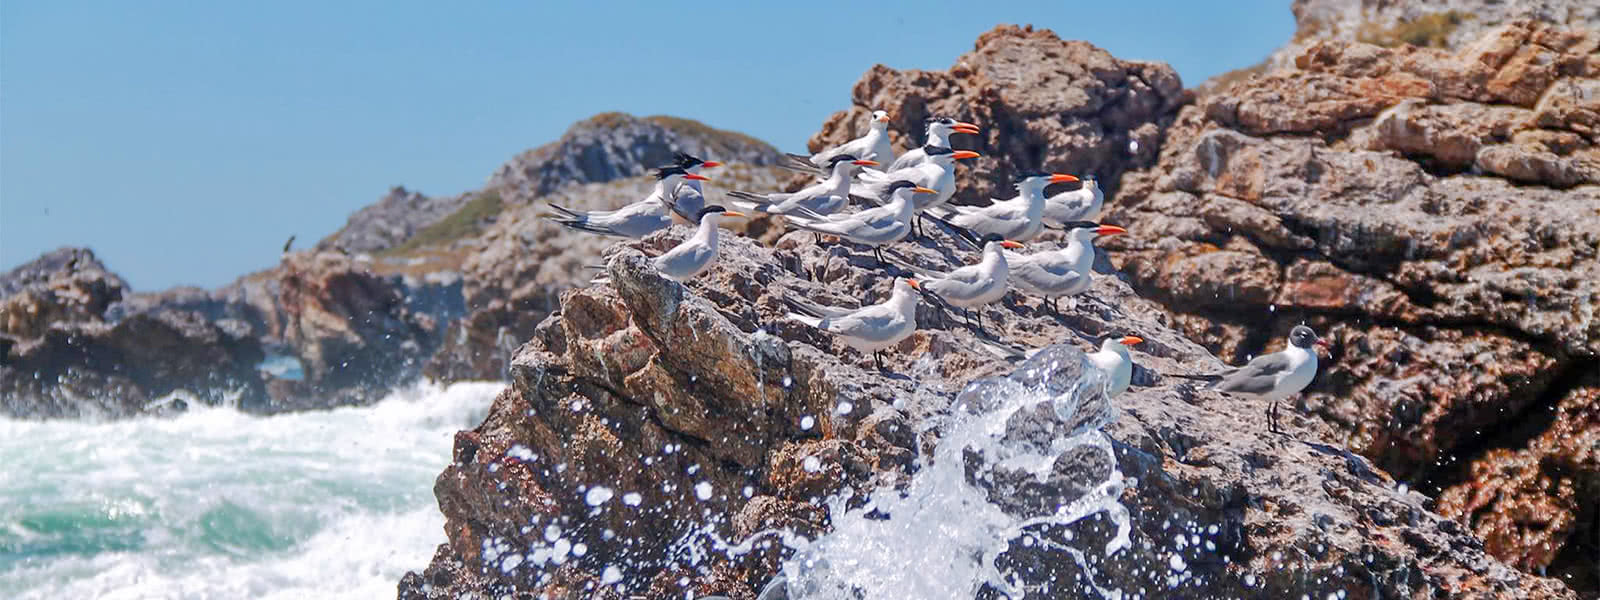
0 382 504 598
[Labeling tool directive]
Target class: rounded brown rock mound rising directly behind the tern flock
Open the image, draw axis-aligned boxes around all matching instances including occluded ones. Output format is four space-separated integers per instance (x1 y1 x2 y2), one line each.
810 26 1187 202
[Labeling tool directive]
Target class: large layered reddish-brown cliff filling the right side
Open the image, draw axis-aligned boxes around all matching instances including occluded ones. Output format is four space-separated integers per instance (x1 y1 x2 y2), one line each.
1107 21 1600 590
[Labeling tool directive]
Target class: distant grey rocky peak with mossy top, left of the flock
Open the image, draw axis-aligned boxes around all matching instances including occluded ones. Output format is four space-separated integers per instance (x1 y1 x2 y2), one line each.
488 112 778 200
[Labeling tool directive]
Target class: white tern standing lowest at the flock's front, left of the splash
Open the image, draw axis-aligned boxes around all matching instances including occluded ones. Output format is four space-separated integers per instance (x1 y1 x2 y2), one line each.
784 277 922 370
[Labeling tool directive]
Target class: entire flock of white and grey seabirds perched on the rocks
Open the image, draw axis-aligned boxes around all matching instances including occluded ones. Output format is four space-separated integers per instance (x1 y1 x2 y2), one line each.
544 110 1325 432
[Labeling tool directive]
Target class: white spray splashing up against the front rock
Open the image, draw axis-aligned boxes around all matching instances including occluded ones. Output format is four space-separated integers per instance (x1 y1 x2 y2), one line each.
782 349 1130 600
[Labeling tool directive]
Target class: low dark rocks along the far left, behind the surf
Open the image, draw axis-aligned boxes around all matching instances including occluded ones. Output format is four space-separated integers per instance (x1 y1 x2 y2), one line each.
0 250 462 418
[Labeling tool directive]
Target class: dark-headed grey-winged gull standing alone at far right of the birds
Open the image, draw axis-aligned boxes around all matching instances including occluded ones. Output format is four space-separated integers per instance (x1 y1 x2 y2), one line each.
1181 325 1328 434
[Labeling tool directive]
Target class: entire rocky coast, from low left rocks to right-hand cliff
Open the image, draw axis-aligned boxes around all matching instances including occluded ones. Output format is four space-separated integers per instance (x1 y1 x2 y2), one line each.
0 0 1600 598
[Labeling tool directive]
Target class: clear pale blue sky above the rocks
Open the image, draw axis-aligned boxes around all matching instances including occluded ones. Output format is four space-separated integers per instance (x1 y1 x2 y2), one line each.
0 0 1293 290
